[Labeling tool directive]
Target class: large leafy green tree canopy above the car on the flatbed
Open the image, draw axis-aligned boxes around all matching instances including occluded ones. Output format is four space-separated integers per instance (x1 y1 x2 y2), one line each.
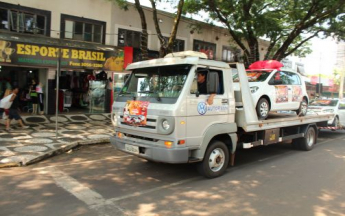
185 0 345 64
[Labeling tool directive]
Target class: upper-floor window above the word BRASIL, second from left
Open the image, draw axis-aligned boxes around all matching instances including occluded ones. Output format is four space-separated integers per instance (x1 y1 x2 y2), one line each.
61 14 106 43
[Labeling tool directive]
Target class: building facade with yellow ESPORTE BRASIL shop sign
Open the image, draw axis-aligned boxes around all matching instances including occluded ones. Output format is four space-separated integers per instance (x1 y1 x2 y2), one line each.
0 0 266 114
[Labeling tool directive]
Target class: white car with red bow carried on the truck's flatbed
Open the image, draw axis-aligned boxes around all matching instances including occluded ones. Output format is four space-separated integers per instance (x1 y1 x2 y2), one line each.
233 68 309 120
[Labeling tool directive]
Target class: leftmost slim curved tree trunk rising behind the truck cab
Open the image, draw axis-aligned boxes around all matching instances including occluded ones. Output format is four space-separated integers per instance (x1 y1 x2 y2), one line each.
135 0 149 60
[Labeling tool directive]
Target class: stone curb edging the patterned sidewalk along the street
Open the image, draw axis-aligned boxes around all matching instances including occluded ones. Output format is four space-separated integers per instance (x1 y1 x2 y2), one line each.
0 138 110 169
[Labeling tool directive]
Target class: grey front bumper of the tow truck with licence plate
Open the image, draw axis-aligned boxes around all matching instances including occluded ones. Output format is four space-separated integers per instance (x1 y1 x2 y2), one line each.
110 137 189 164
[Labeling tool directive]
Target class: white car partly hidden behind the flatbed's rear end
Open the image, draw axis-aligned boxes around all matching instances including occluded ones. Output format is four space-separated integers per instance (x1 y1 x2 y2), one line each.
308 98 345 127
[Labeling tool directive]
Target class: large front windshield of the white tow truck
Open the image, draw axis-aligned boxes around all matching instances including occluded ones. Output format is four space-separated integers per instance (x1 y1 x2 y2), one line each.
119 65 191 103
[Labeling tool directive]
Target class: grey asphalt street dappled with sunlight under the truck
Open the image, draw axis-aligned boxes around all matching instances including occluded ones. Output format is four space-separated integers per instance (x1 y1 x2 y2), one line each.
0 131 345 216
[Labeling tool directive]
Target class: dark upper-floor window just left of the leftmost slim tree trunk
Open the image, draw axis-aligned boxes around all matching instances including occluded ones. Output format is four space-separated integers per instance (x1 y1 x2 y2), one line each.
117 29 141 48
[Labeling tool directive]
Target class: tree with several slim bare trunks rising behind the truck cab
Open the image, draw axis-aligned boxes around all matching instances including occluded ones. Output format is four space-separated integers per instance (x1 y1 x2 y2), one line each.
111 0 184 60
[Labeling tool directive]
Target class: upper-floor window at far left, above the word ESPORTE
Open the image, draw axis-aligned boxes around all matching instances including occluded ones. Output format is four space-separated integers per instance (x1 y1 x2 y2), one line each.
0 2 51 36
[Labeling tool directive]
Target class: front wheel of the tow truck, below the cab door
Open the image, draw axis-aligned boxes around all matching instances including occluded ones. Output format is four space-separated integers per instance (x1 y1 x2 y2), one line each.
197 140 229 178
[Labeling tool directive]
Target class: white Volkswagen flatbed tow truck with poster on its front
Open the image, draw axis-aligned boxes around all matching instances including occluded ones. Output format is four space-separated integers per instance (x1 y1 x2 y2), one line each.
110 51 332 178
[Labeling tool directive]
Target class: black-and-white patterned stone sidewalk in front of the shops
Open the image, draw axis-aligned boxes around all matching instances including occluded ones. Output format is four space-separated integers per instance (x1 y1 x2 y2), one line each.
0 114 114 168
